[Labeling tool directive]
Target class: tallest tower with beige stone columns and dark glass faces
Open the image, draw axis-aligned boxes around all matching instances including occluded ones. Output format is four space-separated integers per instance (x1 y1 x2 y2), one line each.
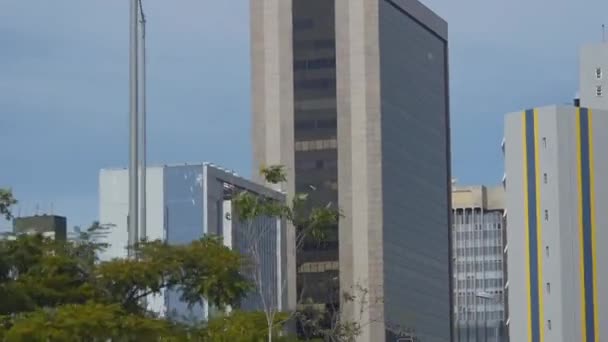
251 0 451 342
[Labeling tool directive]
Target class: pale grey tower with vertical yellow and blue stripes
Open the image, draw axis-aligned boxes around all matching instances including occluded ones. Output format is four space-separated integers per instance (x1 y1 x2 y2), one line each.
505 106 608 342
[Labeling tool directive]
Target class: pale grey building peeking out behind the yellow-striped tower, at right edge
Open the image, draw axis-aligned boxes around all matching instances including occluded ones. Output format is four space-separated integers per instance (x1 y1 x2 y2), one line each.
579 42 608 110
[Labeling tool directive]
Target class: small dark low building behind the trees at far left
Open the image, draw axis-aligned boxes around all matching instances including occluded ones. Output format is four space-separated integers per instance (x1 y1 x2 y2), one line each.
13 215 67 240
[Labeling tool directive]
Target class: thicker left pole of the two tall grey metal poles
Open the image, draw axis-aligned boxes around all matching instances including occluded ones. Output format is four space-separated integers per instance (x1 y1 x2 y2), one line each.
128 0 139 252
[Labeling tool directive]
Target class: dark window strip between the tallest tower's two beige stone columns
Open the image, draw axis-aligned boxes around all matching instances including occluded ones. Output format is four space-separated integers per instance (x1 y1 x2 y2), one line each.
292 0 339 305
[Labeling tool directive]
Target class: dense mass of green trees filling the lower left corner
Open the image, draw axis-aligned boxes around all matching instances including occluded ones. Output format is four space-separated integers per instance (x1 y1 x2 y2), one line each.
0 224 250 342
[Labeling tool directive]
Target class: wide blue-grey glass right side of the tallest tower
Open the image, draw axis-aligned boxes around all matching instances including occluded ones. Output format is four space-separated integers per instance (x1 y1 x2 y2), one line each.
380 0 451 342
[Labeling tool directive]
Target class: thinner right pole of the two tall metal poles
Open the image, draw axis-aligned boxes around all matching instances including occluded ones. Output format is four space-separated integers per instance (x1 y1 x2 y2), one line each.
139 0 148 243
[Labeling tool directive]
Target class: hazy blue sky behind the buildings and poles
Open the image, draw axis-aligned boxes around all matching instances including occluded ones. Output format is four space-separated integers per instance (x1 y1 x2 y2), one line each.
0 0 608 228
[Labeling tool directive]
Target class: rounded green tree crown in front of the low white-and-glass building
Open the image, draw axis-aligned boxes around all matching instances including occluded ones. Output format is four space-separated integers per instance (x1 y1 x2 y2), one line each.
96 237 250 312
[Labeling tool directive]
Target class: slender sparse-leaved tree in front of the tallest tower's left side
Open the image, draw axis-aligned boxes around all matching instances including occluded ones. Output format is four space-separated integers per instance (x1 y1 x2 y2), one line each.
232 166 340 342
